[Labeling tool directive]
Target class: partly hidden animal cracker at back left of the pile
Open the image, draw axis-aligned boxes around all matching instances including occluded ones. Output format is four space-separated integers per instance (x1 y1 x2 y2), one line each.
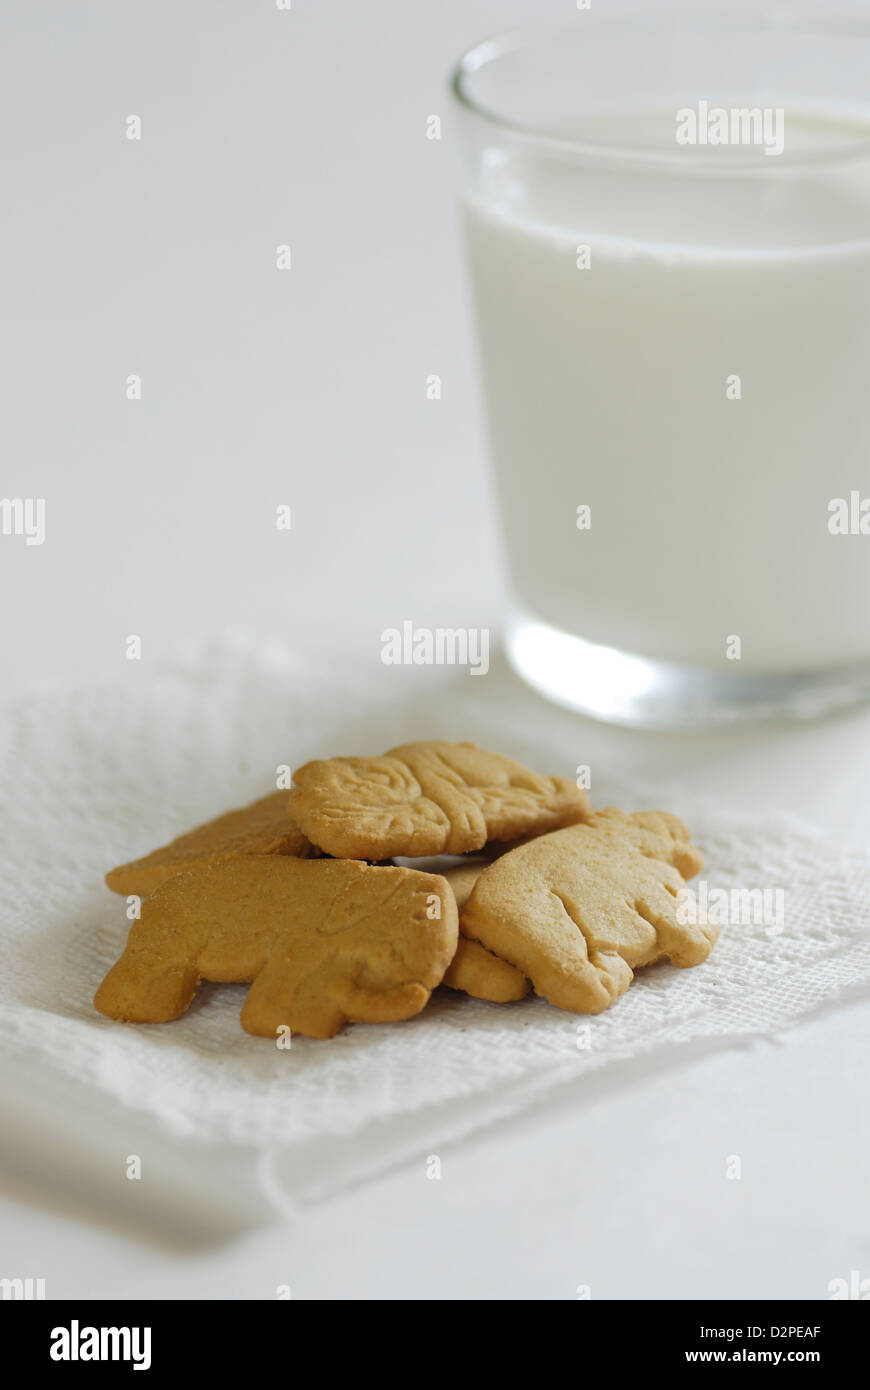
106 791 311 898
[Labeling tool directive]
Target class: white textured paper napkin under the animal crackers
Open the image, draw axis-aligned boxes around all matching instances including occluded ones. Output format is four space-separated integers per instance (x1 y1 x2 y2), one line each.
0 642 870 1195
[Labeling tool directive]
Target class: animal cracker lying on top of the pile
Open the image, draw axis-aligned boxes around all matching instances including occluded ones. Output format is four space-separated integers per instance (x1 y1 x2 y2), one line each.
290 741 588 859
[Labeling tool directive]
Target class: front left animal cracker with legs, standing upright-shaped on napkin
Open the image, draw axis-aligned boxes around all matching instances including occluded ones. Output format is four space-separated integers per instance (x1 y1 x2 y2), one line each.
95 855 457 1038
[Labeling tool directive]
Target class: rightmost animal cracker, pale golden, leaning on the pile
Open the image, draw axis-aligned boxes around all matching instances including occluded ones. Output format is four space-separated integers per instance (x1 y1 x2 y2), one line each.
461 809 708 1013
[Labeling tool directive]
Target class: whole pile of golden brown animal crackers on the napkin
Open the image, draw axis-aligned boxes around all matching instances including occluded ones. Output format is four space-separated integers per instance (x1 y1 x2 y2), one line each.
95 741 716 1038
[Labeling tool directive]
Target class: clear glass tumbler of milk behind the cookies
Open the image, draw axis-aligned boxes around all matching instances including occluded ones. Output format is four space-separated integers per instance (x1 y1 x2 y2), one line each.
453 13 870 728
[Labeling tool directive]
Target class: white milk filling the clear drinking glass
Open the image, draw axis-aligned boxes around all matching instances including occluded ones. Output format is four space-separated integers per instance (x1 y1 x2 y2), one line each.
467 113 870 673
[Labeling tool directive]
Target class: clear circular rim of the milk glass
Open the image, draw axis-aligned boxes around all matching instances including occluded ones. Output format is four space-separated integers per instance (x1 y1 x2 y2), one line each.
448 8 870 177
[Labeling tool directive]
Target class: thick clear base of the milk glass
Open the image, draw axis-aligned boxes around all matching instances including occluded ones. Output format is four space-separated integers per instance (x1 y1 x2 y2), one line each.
507 609 870 730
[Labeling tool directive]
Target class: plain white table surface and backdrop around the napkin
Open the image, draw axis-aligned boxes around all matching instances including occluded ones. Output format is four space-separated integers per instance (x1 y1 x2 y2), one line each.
0 0 870 1298
